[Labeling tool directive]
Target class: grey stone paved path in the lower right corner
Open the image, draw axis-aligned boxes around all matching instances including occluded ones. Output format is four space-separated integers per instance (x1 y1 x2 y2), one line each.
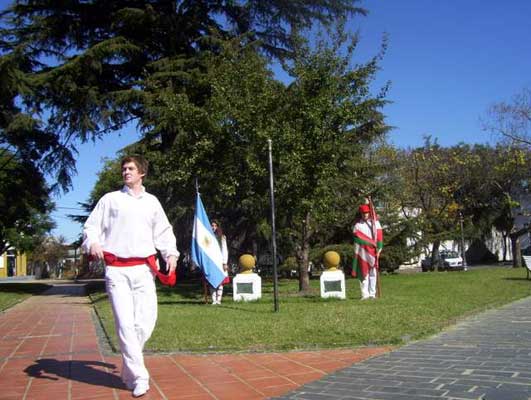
277 298 531 400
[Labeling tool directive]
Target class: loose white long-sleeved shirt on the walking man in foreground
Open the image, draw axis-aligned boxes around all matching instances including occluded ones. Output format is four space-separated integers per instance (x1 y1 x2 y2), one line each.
82 186 179 258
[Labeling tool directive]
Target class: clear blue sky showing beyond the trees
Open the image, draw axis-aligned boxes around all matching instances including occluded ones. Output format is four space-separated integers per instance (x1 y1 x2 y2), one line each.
0 0 531 242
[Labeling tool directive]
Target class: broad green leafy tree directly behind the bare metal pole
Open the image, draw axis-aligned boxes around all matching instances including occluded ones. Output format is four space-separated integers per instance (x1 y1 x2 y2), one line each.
83 26 387 291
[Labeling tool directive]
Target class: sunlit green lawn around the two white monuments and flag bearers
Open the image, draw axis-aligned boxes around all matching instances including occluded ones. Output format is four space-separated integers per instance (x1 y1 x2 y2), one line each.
92 267 531 352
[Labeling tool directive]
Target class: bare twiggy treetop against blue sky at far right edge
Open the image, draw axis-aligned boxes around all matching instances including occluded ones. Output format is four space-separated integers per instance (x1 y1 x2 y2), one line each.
483 88 531 146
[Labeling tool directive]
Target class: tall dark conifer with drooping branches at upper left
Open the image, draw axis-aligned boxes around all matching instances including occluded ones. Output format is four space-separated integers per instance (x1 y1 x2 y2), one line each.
0 0 365 190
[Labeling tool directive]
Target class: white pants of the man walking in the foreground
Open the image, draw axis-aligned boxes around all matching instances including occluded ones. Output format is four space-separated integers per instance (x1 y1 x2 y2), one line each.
105 265 157 388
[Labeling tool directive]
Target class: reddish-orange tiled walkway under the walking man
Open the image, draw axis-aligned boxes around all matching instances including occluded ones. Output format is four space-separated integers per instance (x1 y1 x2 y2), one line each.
0 283 390 400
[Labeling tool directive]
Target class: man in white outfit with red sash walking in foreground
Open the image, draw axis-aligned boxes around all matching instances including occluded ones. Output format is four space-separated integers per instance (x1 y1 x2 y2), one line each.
83 156 179 397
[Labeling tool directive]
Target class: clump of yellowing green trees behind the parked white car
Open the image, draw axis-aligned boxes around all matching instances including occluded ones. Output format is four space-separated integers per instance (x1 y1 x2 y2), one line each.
396 138 531 266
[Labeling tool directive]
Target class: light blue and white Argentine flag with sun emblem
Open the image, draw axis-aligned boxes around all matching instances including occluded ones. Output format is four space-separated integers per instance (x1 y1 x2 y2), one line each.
192 193 227 288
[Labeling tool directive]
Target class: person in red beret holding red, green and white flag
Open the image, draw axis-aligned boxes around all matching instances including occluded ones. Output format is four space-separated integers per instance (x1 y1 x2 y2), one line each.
352 204 383 300
